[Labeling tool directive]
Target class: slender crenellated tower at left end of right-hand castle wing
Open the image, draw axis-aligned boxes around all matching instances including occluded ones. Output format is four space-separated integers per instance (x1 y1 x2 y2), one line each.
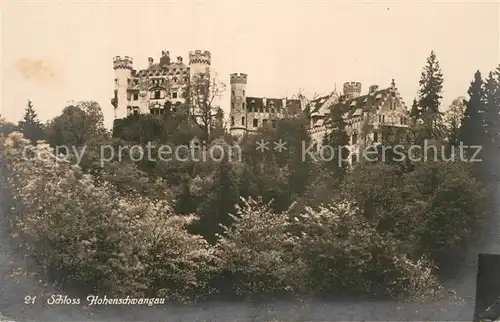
229 73 248 136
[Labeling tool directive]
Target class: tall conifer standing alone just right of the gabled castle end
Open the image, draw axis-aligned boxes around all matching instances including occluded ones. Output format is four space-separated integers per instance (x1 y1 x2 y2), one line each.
418 51 443 138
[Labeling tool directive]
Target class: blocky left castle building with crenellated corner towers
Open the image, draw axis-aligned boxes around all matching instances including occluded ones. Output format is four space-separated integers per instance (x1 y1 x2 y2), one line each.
111 50 211 119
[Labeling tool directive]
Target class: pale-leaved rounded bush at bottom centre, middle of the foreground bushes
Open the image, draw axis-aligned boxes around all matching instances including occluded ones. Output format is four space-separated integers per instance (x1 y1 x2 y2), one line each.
216 199 307 295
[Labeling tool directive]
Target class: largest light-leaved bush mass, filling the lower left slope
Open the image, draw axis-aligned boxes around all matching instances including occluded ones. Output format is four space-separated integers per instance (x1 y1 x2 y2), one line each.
1 134 213 299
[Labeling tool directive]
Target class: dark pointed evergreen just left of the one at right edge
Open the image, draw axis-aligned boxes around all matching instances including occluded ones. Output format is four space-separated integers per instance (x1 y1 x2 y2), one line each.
460 70 485 145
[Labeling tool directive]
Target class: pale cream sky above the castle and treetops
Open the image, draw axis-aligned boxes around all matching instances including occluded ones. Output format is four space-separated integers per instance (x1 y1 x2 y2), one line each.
0 0 500 127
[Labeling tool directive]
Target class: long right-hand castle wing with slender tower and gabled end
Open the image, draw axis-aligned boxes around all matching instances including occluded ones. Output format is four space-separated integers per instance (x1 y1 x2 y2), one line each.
230 73 409 146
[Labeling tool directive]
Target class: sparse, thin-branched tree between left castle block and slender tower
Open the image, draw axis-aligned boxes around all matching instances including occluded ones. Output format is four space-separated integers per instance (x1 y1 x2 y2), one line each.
185 73 226 140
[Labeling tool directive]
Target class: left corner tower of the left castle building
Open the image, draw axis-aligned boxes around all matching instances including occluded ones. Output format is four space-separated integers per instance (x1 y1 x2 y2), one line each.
111 56 133 119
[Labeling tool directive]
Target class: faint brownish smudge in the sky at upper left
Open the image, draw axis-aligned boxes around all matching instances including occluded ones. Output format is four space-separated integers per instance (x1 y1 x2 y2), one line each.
14 58 62 86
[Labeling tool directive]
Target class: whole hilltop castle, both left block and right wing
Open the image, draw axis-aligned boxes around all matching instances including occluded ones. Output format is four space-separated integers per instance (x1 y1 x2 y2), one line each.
111 50 409 145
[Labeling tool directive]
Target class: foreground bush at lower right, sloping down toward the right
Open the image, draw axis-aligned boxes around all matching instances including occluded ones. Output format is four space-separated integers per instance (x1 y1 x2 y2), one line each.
295 202 440 298
